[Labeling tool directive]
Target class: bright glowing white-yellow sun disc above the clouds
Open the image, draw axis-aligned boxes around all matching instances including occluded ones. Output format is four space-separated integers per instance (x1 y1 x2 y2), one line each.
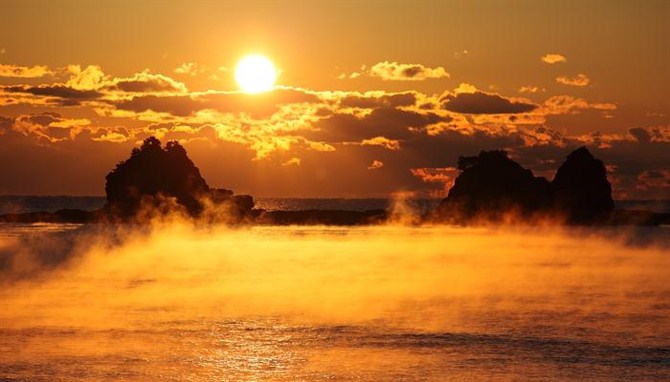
235 54 278 94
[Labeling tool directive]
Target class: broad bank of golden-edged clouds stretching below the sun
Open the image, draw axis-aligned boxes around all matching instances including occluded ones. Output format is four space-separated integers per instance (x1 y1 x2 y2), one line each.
0 61 670 198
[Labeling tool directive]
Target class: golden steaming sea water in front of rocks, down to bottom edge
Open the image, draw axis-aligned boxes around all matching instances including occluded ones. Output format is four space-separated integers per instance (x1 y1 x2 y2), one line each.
0 221 670 381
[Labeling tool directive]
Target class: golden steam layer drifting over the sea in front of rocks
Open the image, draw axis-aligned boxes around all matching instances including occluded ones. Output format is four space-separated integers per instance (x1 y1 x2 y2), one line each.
0 220 670 330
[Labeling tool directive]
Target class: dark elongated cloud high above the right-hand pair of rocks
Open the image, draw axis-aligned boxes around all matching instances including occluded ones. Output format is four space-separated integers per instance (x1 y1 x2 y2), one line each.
442 91 537 114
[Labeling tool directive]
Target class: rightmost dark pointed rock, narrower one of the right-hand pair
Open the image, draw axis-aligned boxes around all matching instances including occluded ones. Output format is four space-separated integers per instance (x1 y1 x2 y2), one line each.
551 147 614 223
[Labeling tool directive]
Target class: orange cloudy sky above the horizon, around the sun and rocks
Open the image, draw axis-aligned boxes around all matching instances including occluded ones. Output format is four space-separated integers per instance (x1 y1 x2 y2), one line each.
0 0 670 199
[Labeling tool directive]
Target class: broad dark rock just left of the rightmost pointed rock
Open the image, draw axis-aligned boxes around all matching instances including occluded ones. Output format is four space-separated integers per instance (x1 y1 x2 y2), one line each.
437 151 551 222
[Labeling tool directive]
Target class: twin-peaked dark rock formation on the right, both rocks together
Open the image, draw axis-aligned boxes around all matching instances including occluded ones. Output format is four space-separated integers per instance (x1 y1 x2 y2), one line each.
436 147 614 223
